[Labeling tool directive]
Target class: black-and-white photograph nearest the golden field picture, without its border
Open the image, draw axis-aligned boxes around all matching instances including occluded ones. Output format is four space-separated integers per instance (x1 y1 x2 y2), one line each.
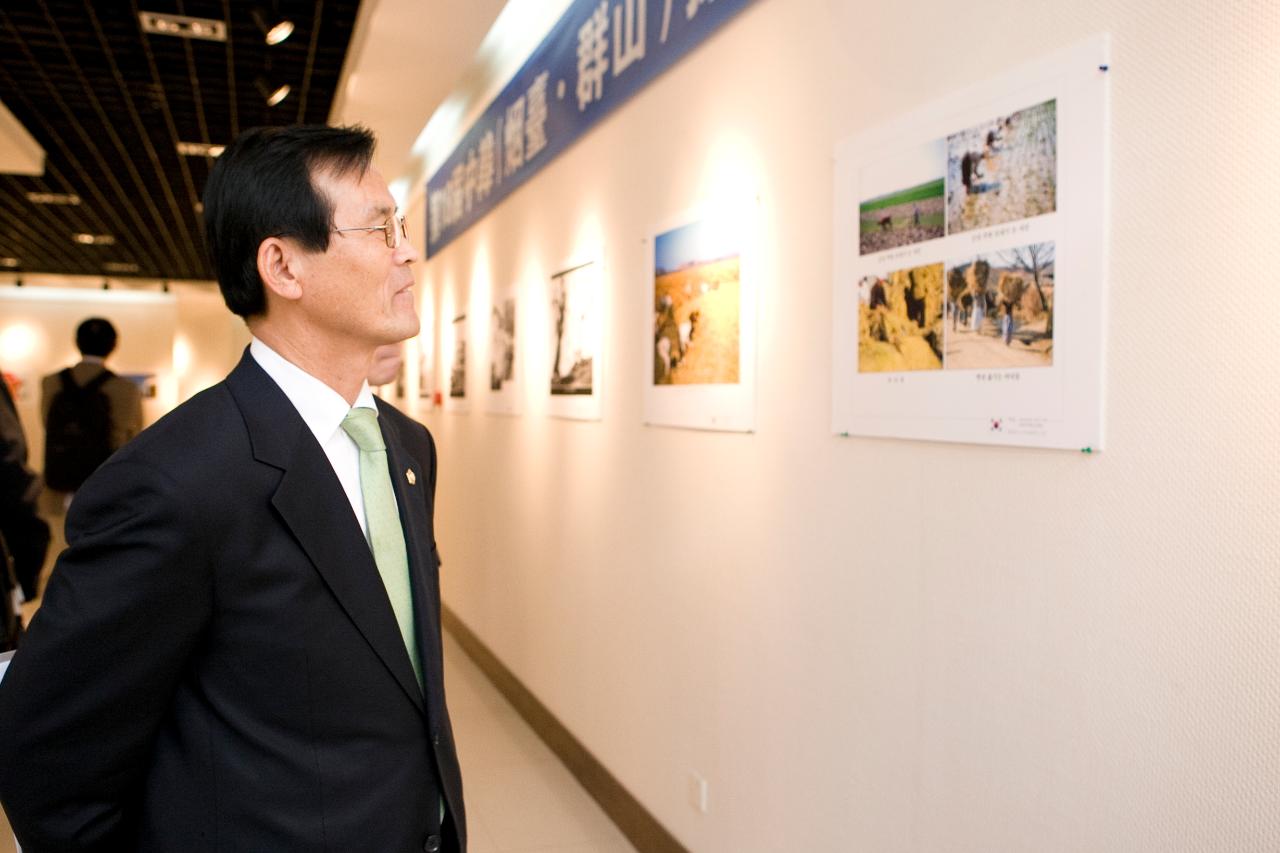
550 264 599 396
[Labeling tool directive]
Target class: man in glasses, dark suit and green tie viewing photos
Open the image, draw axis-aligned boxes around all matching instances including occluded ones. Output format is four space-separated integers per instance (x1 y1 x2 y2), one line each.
0 127 466 853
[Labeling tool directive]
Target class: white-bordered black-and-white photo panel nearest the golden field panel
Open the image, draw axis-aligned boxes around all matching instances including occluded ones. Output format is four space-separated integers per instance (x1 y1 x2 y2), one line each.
547 261 604 420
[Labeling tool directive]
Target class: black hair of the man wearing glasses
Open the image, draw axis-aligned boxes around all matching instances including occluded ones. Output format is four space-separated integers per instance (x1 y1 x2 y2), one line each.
205 124 375 318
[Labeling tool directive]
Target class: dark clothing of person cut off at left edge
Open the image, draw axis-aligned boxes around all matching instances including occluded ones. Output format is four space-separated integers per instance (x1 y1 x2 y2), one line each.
0 378 50 610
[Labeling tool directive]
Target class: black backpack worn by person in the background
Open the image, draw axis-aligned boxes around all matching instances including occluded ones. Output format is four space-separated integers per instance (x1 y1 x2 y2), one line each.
45 368 115 492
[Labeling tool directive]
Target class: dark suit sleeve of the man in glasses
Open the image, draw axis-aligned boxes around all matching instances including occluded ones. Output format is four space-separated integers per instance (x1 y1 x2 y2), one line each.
0 460 212 853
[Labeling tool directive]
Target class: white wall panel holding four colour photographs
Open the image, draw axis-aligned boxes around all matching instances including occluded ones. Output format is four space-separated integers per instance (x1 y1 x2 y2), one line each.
832 36 1110 452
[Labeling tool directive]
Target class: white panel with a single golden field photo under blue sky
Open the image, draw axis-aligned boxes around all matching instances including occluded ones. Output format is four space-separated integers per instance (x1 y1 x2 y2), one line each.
644 204 758 432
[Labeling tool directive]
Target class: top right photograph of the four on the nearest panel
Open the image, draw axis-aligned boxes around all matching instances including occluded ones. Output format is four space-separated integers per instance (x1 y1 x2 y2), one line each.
947 100 1057 234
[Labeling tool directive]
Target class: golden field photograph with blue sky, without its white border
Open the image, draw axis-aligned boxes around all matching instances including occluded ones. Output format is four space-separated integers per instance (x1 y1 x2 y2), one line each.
653 219 741 386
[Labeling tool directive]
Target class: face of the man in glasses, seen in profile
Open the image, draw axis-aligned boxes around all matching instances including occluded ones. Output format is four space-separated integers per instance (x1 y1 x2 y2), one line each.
300 162 419 350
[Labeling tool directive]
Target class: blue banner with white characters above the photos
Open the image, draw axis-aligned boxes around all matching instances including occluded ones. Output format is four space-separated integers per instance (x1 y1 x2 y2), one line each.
426 0 751 257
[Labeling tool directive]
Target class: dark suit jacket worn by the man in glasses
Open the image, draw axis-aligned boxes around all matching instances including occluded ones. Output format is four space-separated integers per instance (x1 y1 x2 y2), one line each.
0 352 466 853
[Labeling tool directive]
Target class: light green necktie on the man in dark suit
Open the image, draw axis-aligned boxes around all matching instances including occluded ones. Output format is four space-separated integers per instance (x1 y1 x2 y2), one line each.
342 407 422 686
